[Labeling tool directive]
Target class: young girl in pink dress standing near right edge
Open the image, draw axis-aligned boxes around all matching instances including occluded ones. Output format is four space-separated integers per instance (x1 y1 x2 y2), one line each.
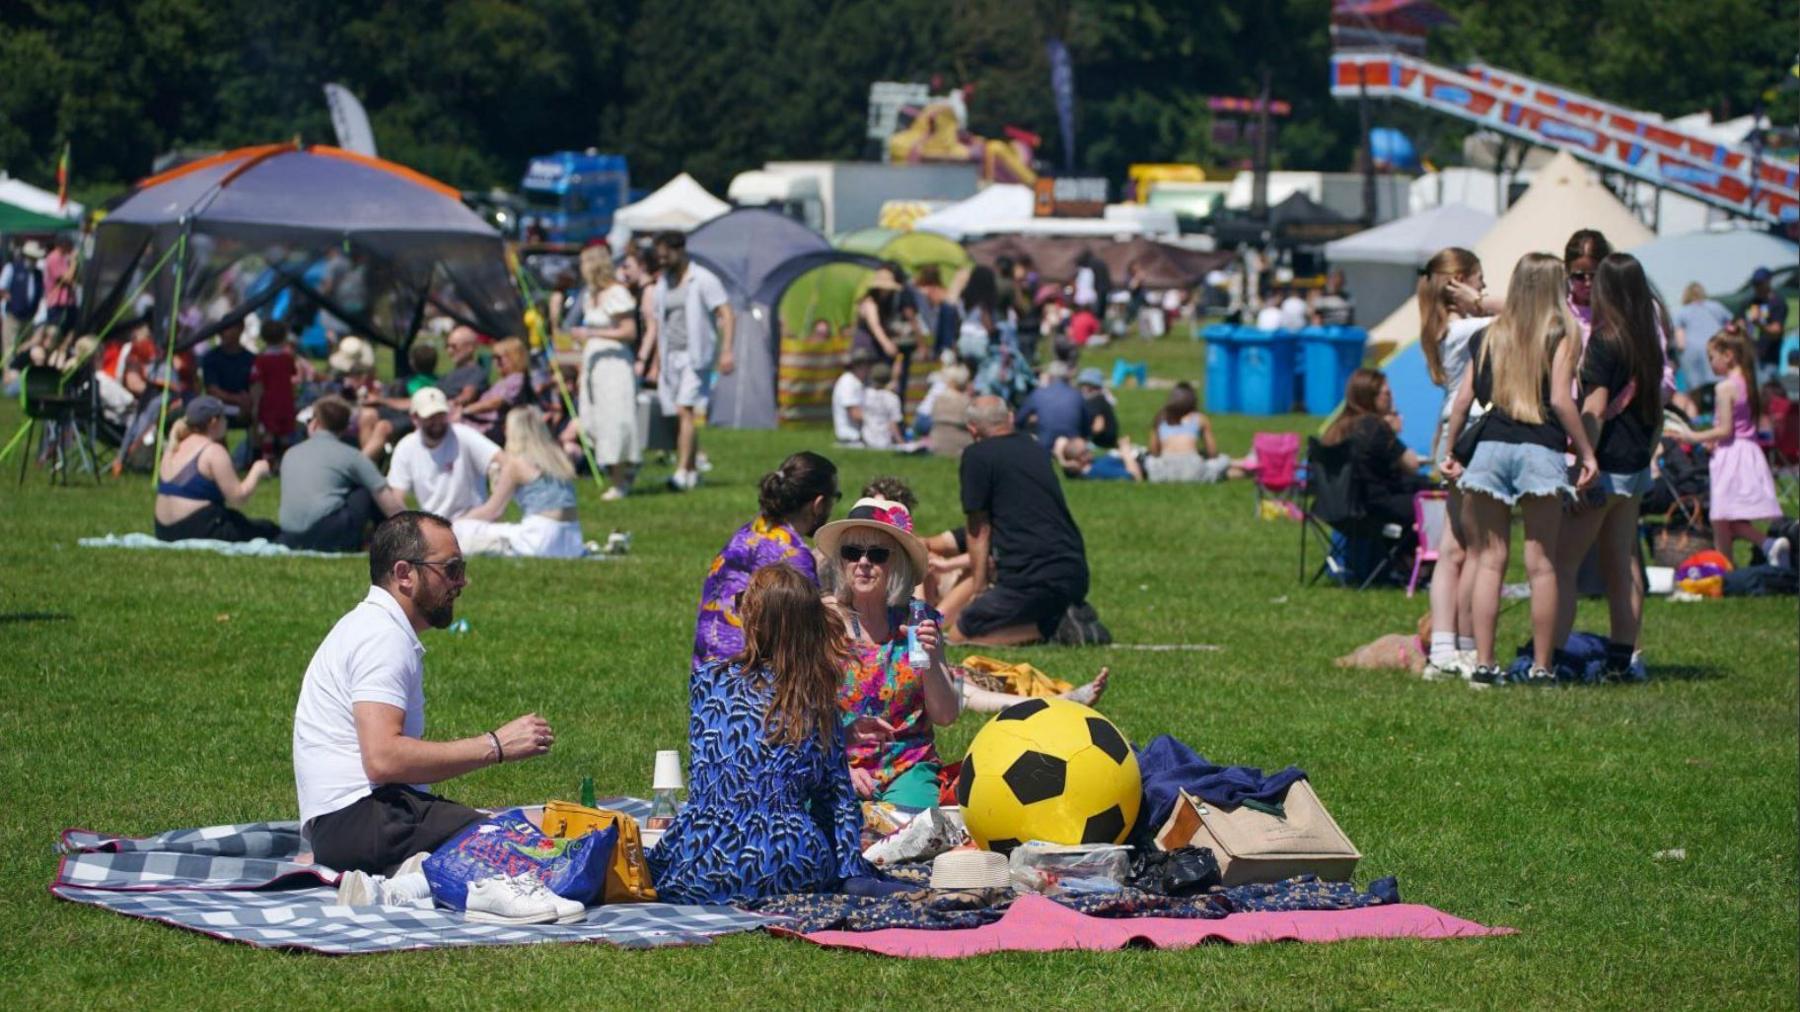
1670 324 1793 565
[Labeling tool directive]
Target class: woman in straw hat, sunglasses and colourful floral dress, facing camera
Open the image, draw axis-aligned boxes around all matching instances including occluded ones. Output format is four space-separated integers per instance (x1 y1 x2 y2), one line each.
817 499 961 809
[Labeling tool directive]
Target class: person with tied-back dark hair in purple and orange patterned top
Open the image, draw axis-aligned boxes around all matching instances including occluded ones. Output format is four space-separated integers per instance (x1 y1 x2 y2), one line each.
691 450 839 672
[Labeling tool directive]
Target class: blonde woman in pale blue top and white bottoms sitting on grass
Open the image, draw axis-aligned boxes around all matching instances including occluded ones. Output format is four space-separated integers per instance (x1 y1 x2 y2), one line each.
457 405 587 558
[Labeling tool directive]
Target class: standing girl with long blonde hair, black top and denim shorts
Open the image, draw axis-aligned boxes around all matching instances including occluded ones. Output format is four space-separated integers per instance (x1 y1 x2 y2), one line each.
1444 254 1598 688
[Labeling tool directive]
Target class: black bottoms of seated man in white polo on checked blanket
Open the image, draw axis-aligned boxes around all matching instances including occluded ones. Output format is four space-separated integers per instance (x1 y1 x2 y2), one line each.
311 783 486 875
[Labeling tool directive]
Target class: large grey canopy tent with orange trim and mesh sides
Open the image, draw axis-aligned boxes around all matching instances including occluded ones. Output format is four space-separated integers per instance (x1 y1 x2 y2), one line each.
81 144 524 349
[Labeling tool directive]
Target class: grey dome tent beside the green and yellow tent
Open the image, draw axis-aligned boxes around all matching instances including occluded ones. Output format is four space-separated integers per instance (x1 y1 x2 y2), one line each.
688 207 882 429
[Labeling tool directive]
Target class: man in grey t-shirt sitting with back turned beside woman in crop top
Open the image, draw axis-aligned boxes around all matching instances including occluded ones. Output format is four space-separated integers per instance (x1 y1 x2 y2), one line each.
281 396 407 551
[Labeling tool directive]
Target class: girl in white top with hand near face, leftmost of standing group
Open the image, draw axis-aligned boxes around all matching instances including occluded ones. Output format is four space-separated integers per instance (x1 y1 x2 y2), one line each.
1418 247 1492 681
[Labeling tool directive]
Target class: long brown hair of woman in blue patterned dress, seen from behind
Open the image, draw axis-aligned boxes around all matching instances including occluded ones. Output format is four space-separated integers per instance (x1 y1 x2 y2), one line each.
733 562 850 745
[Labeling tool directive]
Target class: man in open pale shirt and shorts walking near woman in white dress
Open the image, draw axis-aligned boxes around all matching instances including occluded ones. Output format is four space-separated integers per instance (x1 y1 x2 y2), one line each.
650 232 736 492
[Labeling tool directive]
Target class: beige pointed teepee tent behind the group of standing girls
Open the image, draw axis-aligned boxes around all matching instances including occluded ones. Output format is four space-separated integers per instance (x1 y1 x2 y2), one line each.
1370 151 1654 349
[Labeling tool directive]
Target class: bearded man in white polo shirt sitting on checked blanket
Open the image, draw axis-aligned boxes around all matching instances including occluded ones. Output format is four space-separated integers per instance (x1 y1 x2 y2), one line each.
293 511 556 875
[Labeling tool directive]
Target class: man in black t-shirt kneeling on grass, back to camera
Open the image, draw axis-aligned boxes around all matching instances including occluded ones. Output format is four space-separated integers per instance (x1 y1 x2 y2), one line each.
945 396 1087 646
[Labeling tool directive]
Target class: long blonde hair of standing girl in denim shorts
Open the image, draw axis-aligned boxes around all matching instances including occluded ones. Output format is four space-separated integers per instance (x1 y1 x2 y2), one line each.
1476 254 1580 425
